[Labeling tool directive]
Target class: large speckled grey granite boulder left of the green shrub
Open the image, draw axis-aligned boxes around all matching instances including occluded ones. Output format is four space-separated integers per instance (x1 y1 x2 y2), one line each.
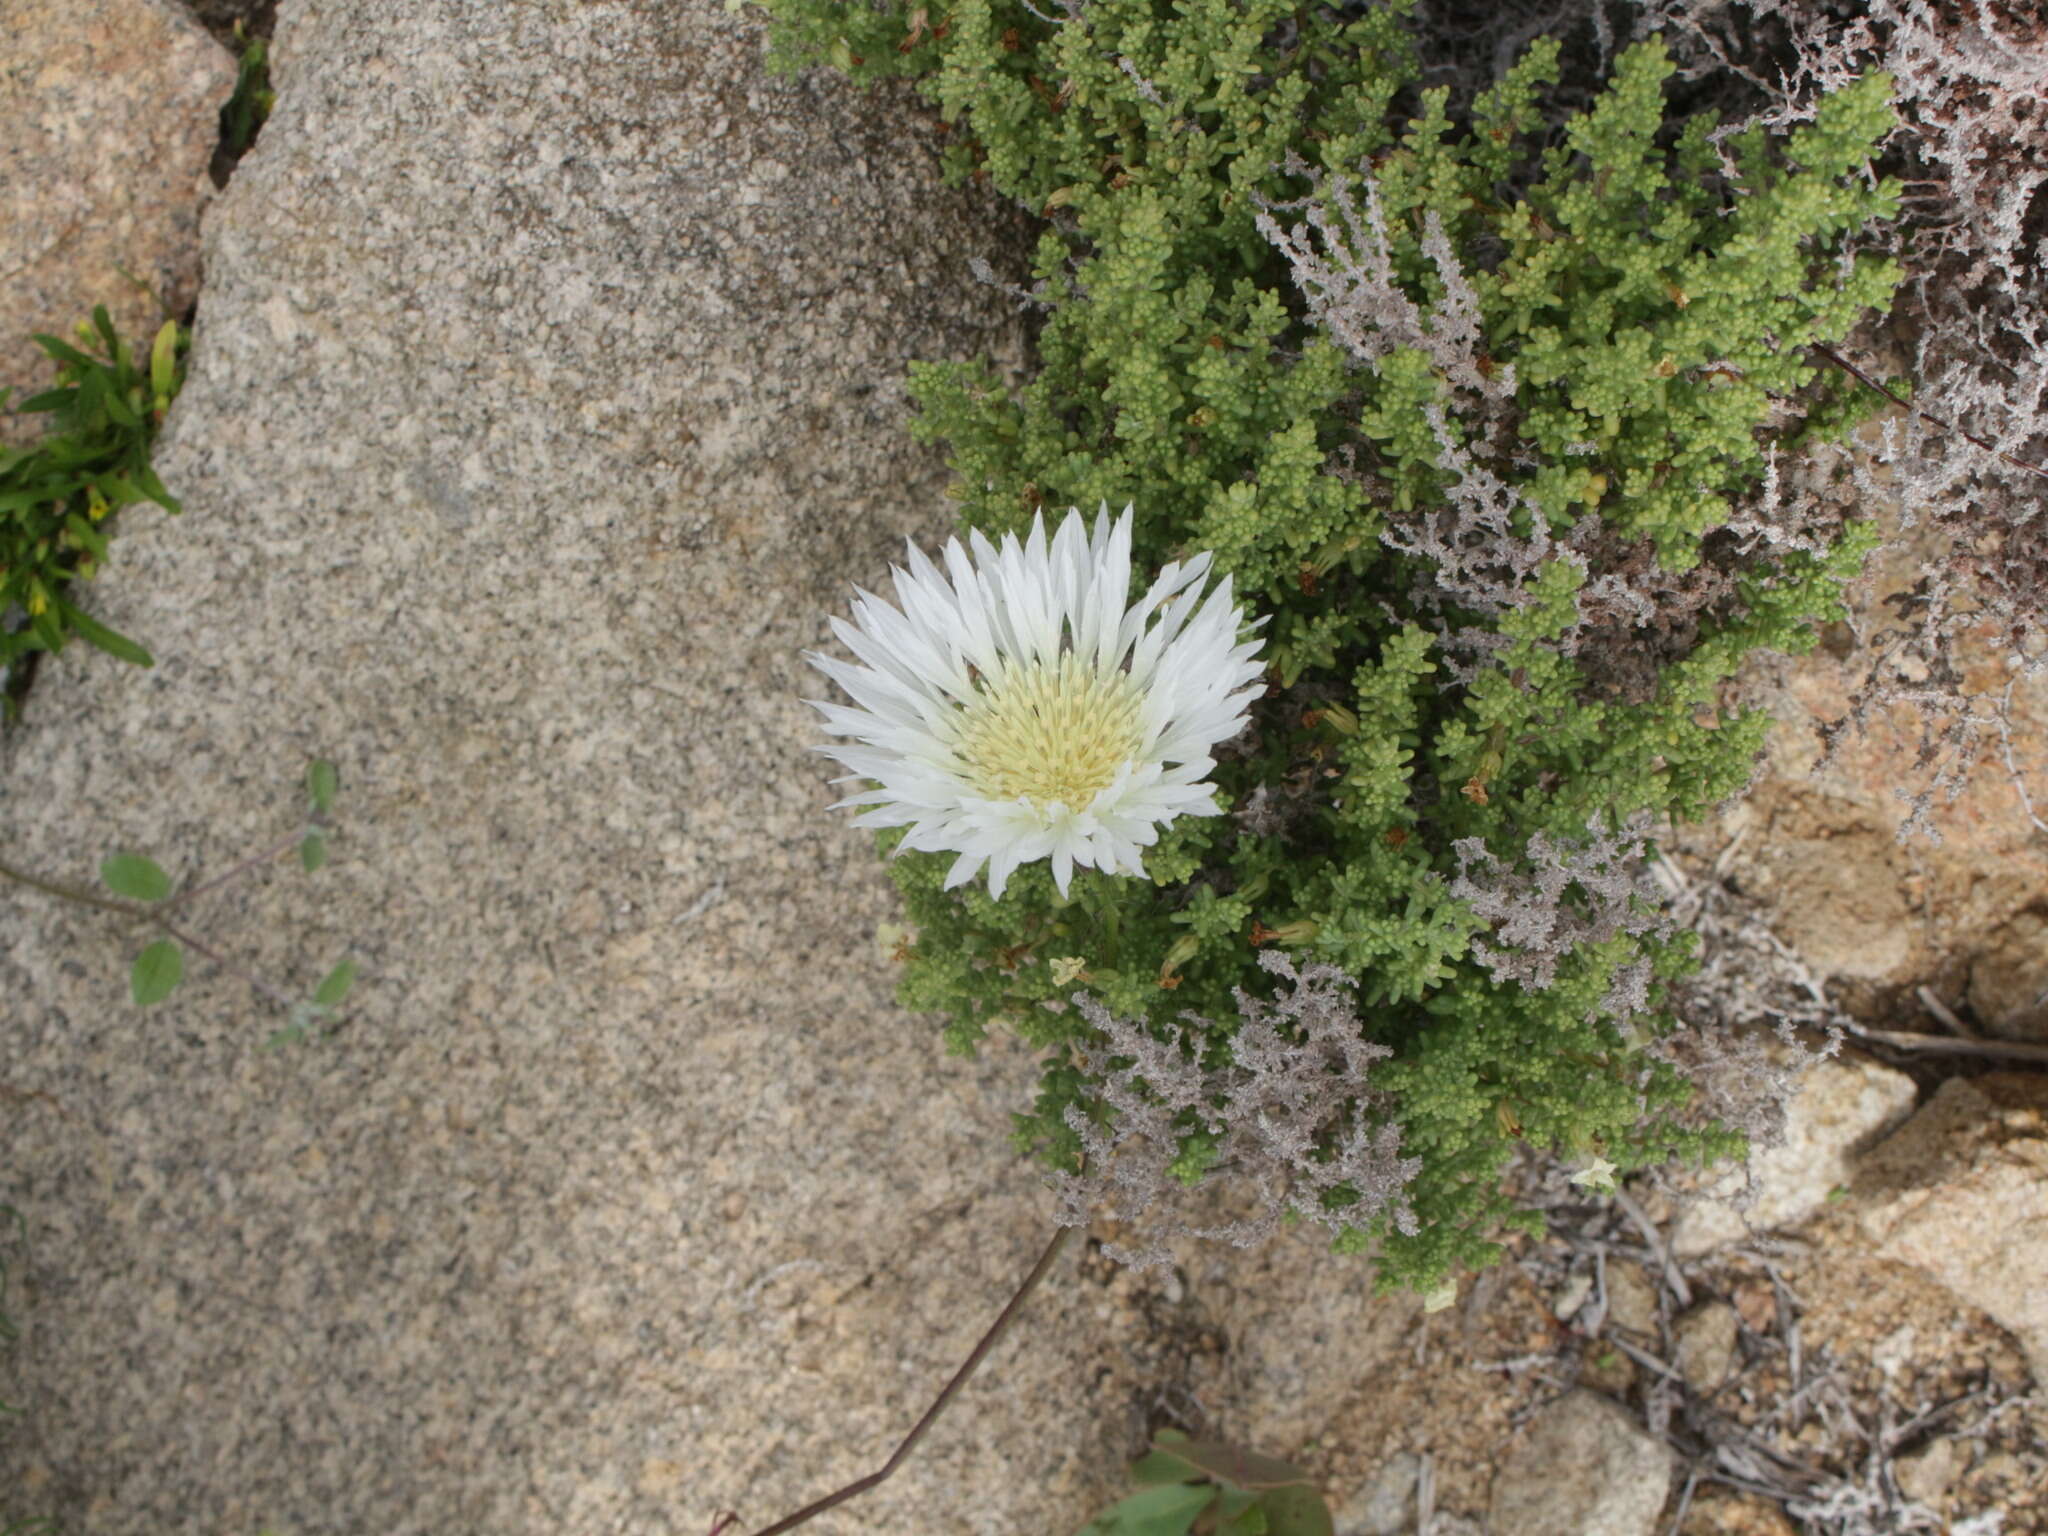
0 0 1413 1536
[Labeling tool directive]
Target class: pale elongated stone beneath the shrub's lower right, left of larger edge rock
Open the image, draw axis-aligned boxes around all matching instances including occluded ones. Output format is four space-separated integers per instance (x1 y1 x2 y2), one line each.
1671 1051 1915 1257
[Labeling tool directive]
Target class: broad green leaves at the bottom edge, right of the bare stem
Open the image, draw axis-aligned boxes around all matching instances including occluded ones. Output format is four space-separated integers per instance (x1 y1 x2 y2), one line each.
1079 1430 1333 1536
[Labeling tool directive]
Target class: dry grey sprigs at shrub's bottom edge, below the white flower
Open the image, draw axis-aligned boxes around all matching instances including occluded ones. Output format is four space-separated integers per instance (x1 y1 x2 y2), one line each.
1053 950 1419 1268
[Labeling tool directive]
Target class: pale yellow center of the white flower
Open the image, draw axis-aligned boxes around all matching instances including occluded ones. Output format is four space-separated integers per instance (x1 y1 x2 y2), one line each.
954 651 1141 811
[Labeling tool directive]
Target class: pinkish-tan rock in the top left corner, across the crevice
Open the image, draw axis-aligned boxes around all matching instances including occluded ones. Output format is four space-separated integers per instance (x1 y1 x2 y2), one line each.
0 0 236 436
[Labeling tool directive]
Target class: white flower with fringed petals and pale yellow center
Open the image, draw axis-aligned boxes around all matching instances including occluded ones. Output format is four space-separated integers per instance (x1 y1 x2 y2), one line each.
807 504 1262 897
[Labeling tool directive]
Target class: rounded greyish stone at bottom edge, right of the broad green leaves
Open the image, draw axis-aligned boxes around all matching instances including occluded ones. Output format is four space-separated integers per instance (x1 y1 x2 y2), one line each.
1491 1391 1671 1536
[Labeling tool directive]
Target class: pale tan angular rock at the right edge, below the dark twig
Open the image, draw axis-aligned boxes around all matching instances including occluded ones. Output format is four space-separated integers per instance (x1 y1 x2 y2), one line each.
1855 1073 2048 1382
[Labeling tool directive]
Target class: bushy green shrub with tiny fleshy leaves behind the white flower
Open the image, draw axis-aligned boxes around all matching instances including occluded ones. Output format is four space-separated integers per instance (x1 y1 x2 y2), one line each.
768 0 1898 1290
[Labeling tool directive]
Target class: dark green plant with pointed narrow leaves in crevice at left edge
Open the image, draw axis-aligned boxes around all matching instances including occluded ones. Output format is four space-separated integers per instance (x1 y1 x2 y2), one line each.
0 307 190 713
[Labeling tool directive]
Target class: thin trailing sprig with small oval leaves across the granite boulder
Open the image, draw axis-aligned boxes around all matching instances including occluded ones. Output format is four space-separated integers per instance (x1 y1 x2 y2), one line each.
0 758 356 1049
